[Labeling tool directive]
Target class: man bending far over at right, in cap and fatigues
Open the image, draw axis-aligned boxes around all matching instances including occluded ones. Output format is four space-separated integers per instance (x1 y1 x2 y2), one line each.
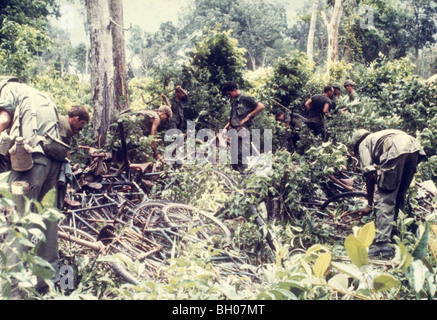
351 129 426 256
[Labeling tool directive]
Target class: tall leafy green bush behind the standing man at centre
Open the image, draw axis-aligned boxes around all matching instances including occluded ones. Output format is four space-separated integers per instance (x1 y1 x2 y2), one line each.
182 30 249 132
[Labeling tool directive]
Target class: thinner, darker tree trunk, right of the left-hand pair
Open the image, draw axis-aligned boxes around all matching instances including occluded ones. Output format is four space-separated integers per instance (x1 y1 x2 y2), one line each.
109 0 129 111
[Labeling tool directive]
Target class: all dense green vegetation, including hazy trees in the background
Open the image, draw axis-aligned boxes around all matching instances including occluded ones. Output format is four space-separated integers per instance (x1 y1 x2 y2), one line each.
0 1 437 299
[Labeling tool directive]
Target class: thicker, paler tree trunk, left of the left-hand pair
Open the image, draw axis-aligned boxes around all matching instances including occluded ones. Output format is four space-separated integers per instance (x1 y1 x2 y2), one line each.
86 0 116 146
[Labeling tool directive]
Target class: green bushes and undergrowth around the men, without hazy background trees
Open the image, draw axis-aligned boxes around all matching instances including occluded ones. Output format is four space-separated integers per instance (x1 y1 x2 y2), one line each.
0 1 437 300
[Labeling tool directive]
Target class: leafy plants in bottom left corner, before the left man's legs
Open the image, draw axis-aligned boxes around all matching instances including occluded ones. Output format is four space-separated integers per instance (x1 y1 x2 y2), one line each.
0 172 61 299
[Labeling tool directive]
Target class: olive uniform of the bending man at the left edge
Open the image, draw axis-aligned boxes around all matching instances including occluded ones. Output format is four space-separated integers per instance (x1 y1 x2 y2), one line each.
0 83 62 289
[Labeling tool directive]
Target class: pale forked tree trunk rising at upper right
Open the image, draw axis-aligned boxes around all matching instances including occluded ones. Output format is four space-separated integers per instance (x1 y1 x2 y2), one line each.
322 0 343 72
